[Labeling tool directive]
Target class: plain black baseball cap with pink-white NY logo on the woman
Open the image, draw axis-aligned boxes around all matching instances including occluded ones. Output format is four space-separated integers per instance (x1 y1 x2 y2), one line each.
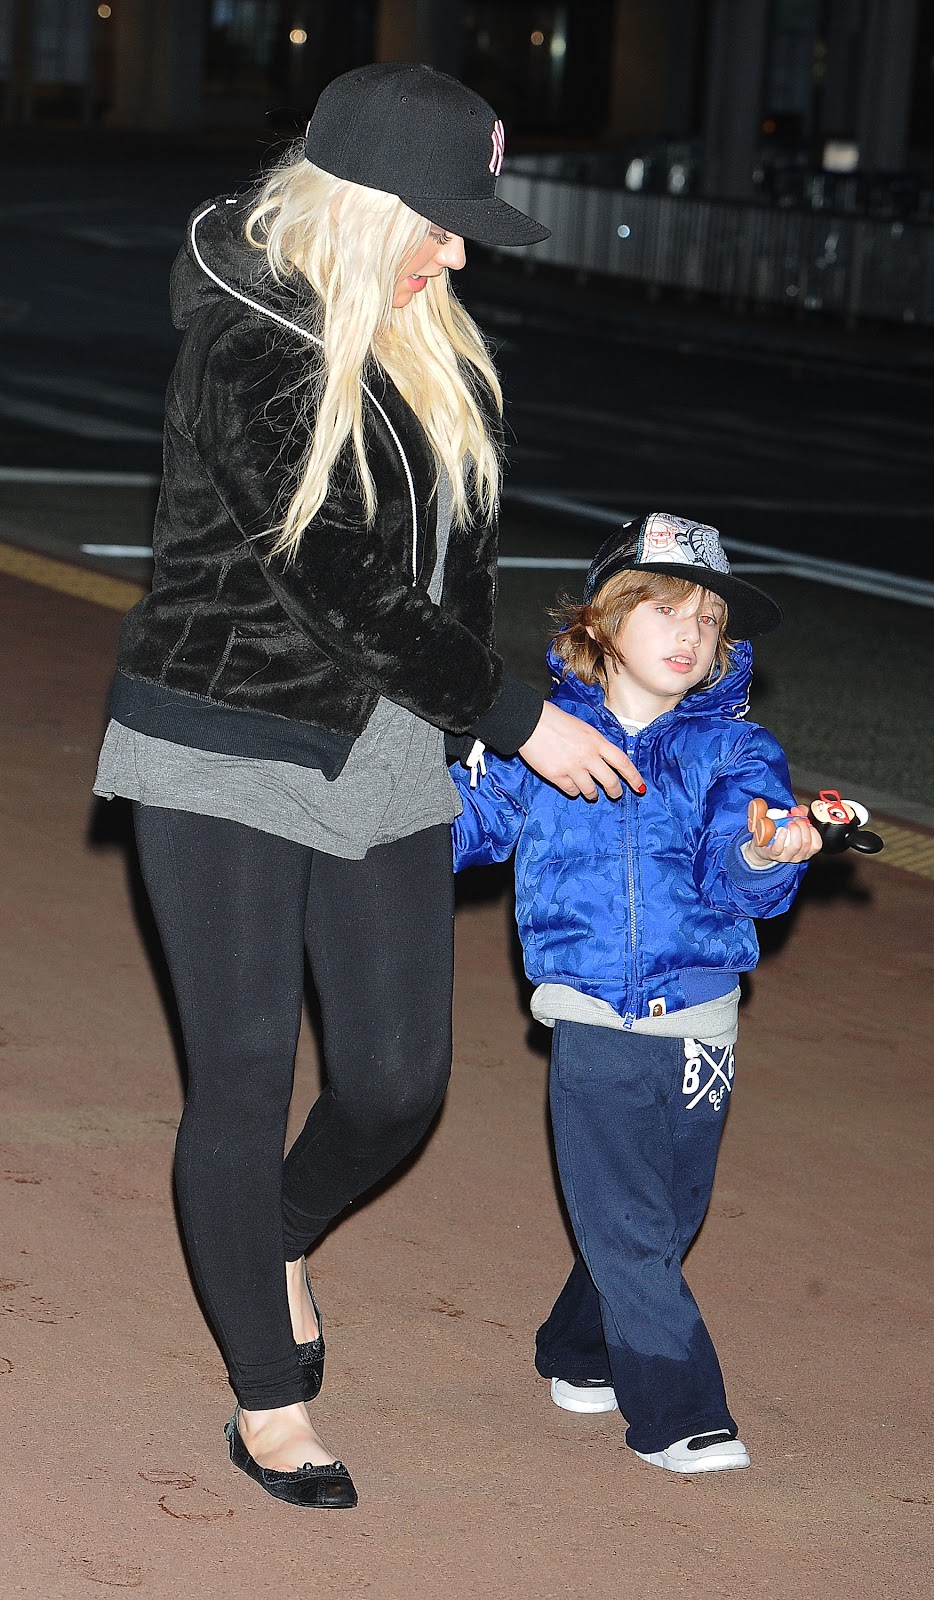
305 61 550 245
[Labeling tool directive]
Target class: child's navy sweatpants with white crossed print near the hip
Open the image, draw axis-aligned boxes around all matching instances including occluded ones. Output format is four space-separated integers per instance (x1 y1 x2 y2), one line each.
536 1022 737 1451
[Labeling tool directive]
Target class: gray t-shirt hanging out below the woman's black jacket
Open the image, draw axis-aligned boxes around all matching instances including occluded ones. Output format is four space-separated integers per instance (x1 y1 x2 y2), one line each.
94 474 461 861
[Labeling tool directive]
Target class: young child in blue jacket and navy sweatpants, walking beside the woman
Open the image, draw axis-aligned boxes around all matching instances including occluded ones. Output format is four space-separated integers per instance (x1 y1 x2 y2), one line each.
454 512 820 1472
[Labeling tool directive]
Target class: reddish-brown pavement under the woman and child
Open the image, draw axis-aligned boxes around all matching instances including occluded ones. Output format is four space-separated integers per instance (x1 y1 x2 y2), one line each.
0 540 934 1600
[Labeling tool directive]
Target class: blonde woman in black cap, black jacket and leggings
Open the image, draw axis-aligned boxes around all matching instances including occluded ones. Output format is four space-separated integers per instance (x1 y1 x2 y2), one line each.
96 64 640 1506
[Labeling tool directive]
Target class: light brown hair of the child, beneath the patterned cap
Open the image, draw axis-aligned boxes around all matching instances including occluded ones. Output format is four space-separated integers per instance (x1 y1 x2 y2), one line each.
552 570 732 690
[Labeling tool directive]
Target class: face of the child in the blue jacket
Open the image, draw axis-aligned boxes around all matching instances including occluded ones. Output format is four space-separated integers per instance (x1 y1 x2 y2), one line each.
605 589 724 722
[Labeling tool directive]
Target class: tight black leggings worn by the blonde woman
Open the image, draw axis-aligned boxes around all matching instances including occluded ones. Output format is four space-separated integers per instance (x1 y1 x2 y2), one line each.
134 805 454 1410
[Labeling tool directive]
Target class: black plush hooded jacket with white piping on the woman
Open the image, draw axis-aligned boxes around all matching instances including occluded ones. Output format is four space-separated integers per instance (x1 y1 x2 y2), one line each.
110 197 542 778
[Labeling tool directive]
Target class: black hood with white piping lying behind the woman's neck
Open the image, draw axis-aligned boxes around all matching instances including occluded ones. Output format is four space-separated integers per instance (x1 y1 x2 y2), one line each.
170 192 315 328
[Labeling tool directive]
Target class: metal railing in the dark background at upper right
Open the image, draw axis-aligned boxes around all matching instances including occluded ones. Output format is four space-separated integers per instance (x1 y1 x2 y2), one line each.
499 170 934 325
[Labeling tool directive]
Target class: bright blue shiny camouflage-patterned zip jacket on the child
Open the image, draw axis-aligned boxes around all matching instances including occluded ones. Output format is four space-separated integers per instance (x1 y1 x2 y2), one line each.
451 643 804 1024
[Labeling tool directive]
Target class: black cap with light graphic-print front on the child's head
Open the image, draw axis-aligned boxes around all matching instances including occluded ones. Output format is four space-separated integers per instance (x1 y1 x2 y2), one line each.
584 510 782 638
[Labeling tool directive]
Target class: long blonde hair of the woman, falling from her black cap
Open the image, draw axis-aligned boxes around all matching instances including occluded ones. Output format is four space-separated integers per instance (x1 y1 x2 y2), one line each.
246 146 502 560
